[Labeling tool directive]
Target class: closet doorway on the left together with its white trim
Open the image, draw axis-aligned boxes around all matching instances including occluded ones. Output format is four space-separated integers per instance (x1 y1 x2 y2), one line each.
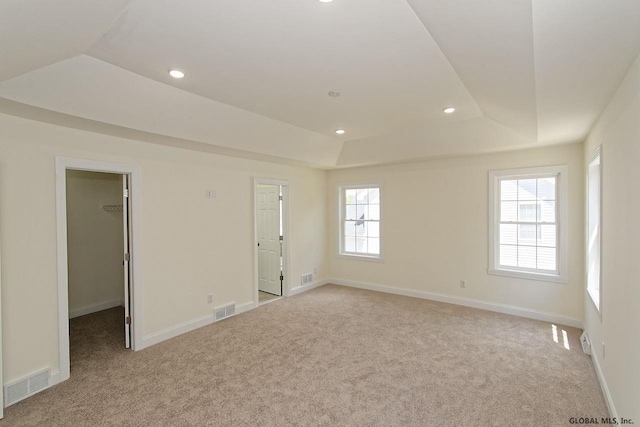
52 157 141 384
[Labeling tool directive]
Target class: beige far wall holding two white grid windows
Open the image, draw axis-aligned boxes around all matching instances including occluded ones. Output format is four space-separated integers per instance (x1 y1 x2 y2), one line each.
327 144 584 320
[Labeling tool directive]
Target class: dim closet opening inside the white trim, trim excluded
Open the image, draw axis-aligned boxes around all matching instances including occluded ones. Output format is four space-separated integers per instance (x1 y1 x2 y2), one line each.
66 169 131 354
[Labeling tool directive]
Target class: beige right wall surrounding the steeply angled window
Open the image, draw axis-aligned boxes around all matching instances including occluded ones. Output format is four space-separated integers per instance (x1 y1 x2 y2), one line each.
584 52 640 424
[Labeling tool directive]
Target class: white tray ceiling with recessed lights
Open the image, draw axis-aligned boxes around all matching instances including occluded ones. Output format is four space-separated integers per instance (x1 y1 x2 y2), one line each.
0 0 640 168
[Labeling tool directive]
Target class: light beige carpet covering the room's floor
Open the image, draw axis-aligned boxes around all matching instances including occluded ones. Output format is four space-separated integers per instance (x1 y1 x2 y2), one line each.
0 285 608 427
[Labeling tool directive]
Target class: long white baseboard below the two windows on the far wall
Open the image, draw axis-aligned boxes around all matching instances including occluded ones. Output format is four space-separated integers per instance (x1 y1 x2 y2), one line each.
327 279 582 329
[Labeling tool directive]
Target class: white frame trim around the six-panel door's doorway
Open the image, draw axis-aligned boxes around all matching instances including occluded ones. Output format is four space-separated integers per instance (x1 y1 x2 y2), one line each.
253 177 291 307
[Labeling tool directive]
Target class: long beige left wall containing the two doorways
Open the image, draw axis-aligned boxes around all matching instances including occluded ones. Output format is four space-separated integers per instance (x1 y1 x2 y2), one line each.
0 115 328 382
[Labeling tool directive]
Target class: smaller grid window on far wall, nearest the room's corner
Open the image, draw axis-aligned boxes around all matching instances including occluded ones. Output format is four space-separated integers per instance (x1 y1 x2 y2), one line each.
339 185 380 259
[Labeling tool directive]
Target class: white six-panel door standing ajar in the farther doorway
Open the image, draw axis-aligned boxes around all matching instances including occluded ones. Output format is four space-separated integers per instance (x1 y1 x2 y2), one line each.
256 185 282 295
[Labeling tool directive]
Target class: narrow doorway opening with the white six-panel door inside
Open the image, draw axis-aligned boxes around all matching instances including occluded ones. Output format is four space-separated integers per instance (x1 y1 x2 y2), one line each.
254 179 288 305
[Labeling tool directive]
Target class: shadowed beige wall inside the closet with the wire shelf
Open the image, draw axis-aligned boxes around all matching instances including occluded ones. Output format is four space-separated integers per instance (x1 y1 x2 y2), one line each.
67 170 124 317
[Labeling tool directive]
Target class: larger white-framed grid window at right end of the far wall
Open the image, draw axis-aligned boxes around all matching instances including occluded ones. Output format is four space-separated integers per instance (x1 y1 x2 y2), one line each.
489 166 567 283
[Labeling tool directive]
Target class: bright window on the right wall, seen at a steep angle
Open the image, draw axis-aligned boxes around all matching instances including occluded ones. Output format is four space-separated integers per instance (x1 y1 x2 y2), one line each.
587 147 602 310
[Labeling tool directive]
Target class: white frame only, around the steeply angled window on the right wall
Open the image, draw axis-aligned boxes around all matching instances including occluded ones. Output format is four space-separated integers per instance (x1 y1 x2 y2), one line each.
585 146 602 315
